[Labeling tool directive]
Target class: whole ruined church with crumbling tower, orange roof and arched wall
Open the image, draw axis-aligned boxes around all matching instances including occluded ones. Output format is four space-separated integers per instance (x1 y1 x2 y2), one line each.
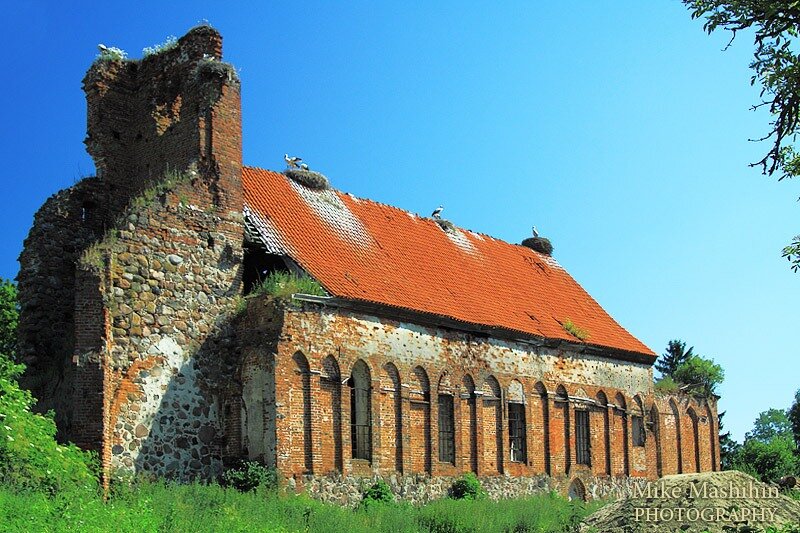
18 25 719 501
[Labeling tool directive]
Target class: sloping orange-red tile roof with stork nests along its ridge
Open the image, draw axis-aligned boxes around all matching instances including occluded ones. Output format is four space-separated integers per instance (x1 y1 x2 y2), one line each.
243 167 655 357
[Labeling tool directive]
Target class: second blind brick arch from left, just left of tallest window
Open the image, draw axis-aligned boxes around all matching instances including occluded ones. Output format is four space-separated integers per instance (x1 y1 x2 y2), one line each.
317 355 343 473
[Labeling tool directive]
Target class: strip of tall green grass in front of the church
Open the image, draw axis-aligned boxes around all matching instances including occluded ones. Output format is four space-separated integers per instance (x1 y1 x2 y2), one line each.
0 482 597 533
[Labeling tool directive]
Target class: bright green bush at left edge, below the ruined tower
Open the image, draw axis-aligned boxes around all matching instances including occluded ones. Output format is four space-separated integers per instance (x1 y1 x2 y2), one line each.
0 354 97 494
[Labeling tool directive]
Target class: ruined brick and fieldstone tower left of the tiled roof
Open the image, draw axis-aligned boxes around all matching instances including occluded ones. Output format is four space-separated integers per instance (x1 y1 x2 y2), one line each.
18 26 243 473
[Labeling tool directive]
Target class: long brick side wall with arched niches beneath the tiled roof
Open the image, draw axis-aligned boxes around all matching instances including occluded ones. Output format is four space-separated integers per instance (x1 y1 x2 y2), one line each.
238 304 718 486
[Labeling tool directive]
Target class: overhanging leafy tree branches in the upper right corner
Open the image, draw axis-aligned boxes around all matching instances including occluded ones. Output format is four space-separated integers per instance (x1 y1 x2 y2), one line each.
682 0 800 272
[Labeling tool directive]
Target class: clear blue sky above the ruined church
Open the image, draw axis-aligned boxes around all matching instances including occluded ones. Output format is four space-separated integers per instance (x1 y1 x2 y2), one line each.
0 0 800 439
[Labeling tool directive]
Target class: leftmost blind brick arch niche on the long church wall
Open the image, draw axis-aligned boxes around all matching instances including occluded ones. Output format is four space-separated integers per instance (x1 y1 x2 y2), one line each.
288 351 314 474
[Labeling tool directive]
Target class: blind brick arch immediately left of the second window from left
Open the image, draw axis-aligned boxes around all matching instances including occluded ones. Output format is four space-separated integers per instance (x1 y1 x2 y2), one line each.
408 365 433 474
